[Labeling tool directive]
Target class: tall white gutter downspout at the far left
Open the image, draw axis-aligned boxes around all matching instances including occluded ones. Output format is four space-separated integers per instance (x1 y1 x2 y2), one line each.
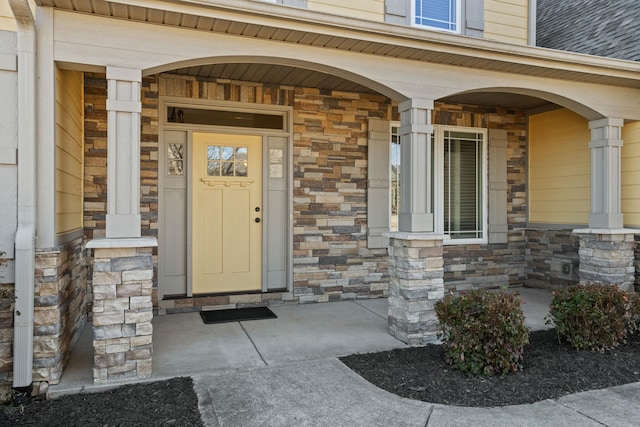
9 0 37 404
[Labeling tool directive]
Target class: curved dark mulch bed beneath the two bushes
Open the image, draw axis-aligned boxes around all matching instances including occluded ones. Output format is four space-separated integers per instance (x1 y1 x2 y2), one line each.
340 330 640 406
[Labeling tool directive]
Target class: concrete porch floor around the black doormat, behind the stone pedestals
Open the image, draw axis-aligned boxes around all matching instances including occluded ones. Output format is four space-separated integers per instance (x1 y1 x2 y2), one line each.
48 288 552 398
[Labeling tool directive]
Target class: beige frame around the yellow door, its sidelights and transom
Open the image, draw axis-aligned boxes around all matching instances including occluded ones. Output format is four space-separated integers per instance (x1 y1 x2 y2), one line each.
158 96 293 300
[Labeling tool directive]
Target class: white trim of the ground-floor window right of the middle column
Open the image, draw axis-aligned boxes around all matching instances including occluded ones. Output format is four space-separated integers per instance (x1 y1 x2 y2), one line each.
433 125 489 245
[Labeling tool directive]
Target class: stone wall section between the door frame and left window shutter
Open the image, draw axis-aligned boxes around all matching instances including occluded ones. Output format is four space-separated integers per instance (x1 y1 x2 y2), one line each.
293 88 395 302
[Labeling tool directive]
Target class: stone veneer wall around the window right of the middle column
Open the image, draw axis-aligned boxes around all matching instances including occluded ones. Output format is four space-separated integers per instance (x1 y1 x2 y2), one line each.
433 102 527 291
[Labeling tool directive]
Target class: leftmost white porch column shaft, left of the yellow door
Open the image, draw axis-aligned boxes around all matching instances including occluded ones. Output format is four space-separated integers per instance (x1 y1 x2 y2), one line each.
106 67 142 238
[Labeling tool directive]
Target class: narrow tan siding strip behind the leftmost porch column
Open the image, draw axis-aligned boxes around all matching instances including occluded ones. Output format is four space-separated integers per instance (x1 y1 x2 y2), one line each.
56 70 84 234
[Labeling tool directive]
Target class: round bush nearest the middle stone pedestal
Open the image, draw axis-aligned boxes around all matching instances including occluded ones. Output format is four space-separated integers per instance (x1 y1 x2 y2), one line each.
435 291 529 376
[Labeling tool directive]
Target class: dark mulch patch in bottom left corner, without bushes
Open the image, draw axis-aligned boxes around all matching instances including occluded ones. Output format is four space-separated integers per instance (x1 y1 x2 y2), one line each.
0 378 203 427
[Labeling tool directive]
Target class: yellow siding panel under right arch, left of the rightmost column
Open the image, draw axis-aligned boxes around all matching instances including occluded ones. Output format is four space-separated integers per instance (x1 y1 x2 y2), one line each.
529 109 591 224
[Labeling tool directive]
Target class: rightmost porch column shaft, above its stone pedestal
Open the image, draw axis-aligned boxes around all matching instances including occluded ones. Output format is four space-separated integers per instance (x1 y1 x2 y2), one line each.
589 118 624 229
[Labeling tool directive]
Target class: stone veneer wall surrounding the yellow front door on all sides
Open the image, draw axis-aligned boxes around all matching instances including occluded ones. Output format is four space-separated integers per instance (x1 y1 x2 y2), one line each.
84 73 397 313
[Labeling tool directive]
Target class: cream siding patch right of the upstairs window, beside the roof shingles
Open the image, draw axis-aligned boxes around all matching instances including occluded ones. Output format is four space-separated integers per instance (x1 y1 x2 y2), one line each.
484 0 529 44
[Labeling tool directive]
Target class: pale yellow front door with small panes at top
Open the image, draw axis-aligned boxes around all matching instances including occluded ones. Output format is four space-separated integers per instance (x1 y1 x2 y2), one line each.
191 133 262 294
